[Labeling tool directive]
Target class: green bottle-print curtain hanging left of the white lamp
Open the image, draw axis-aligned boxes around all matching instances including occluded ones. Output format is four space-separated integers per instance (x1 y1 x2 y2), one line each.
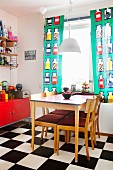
43 16 64 93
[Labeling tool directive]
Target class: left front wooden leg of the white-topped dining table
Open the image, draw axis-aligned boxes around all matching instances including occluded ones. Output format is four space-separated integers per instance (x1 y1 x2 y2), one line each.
31 102 35 150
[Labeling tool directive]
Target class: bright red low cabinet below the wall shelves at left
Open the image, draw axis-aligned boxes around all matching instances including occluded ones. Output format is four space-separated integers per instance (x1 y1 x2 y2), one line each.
0 98 30 127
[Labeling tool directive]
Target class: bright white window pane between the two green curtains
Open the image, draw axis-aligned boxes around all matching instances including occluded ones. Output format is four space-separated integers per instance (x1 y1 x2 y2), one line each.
62 19 91 90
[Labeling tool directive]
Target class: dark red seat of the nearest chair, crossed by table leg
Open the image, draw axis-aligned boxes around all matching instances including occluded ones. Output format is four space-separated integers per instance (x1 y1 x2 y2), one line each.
58 114 86 127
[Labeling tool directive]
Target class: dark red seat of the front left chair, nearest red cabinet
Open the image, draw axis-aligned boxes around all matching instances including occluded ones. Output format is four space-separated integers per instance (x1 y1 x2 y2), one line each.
35 114 64 124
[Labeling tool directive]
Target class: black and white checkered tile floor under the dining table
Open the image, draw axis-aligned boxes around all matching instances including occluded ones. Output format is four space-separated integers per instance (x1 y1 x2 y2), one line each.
0 122 113 170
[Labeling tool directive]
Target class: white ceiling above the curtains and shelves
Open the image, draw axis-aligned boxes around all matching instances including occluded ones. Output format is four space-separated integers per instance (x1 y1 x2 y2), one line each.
0 0 110 17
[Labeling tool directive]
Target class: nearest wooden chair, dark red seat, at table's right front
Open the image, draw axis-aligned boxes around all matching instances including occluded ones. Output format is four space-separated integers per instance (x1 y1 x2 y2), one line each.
57 98 96 160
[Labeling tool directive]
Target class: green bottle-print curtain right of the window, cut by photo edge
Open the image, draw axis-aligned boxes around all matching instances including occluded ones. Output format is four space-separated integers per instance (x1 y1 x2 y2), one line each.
90 7 113 102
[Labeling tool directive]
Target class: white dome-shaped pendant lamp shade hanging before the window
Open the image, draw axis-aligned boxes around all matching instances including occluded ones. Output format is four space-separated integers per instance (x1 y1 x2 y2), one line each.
59 38 81 53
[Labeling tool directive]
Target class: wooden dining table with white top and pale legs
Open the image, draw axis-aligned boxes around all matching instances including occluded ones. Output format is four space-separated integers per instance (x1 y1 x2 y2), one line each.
30 94 92 162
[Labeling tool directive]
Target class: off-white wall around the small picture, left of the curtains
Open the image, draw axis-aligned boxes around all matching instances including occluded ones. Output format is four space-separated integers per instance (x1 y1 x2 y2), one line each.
18 14 44 94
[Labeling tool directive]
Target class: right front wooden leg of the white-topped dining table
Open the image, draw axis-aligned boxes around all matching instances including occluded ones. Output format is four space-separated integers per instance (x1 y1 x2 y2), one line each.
75 106 79 162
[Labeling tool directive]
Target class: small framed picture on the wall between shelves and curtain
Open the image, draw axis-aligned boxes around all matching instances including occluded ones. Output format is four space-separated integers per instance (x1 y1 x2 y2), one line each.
25 50 36 60
